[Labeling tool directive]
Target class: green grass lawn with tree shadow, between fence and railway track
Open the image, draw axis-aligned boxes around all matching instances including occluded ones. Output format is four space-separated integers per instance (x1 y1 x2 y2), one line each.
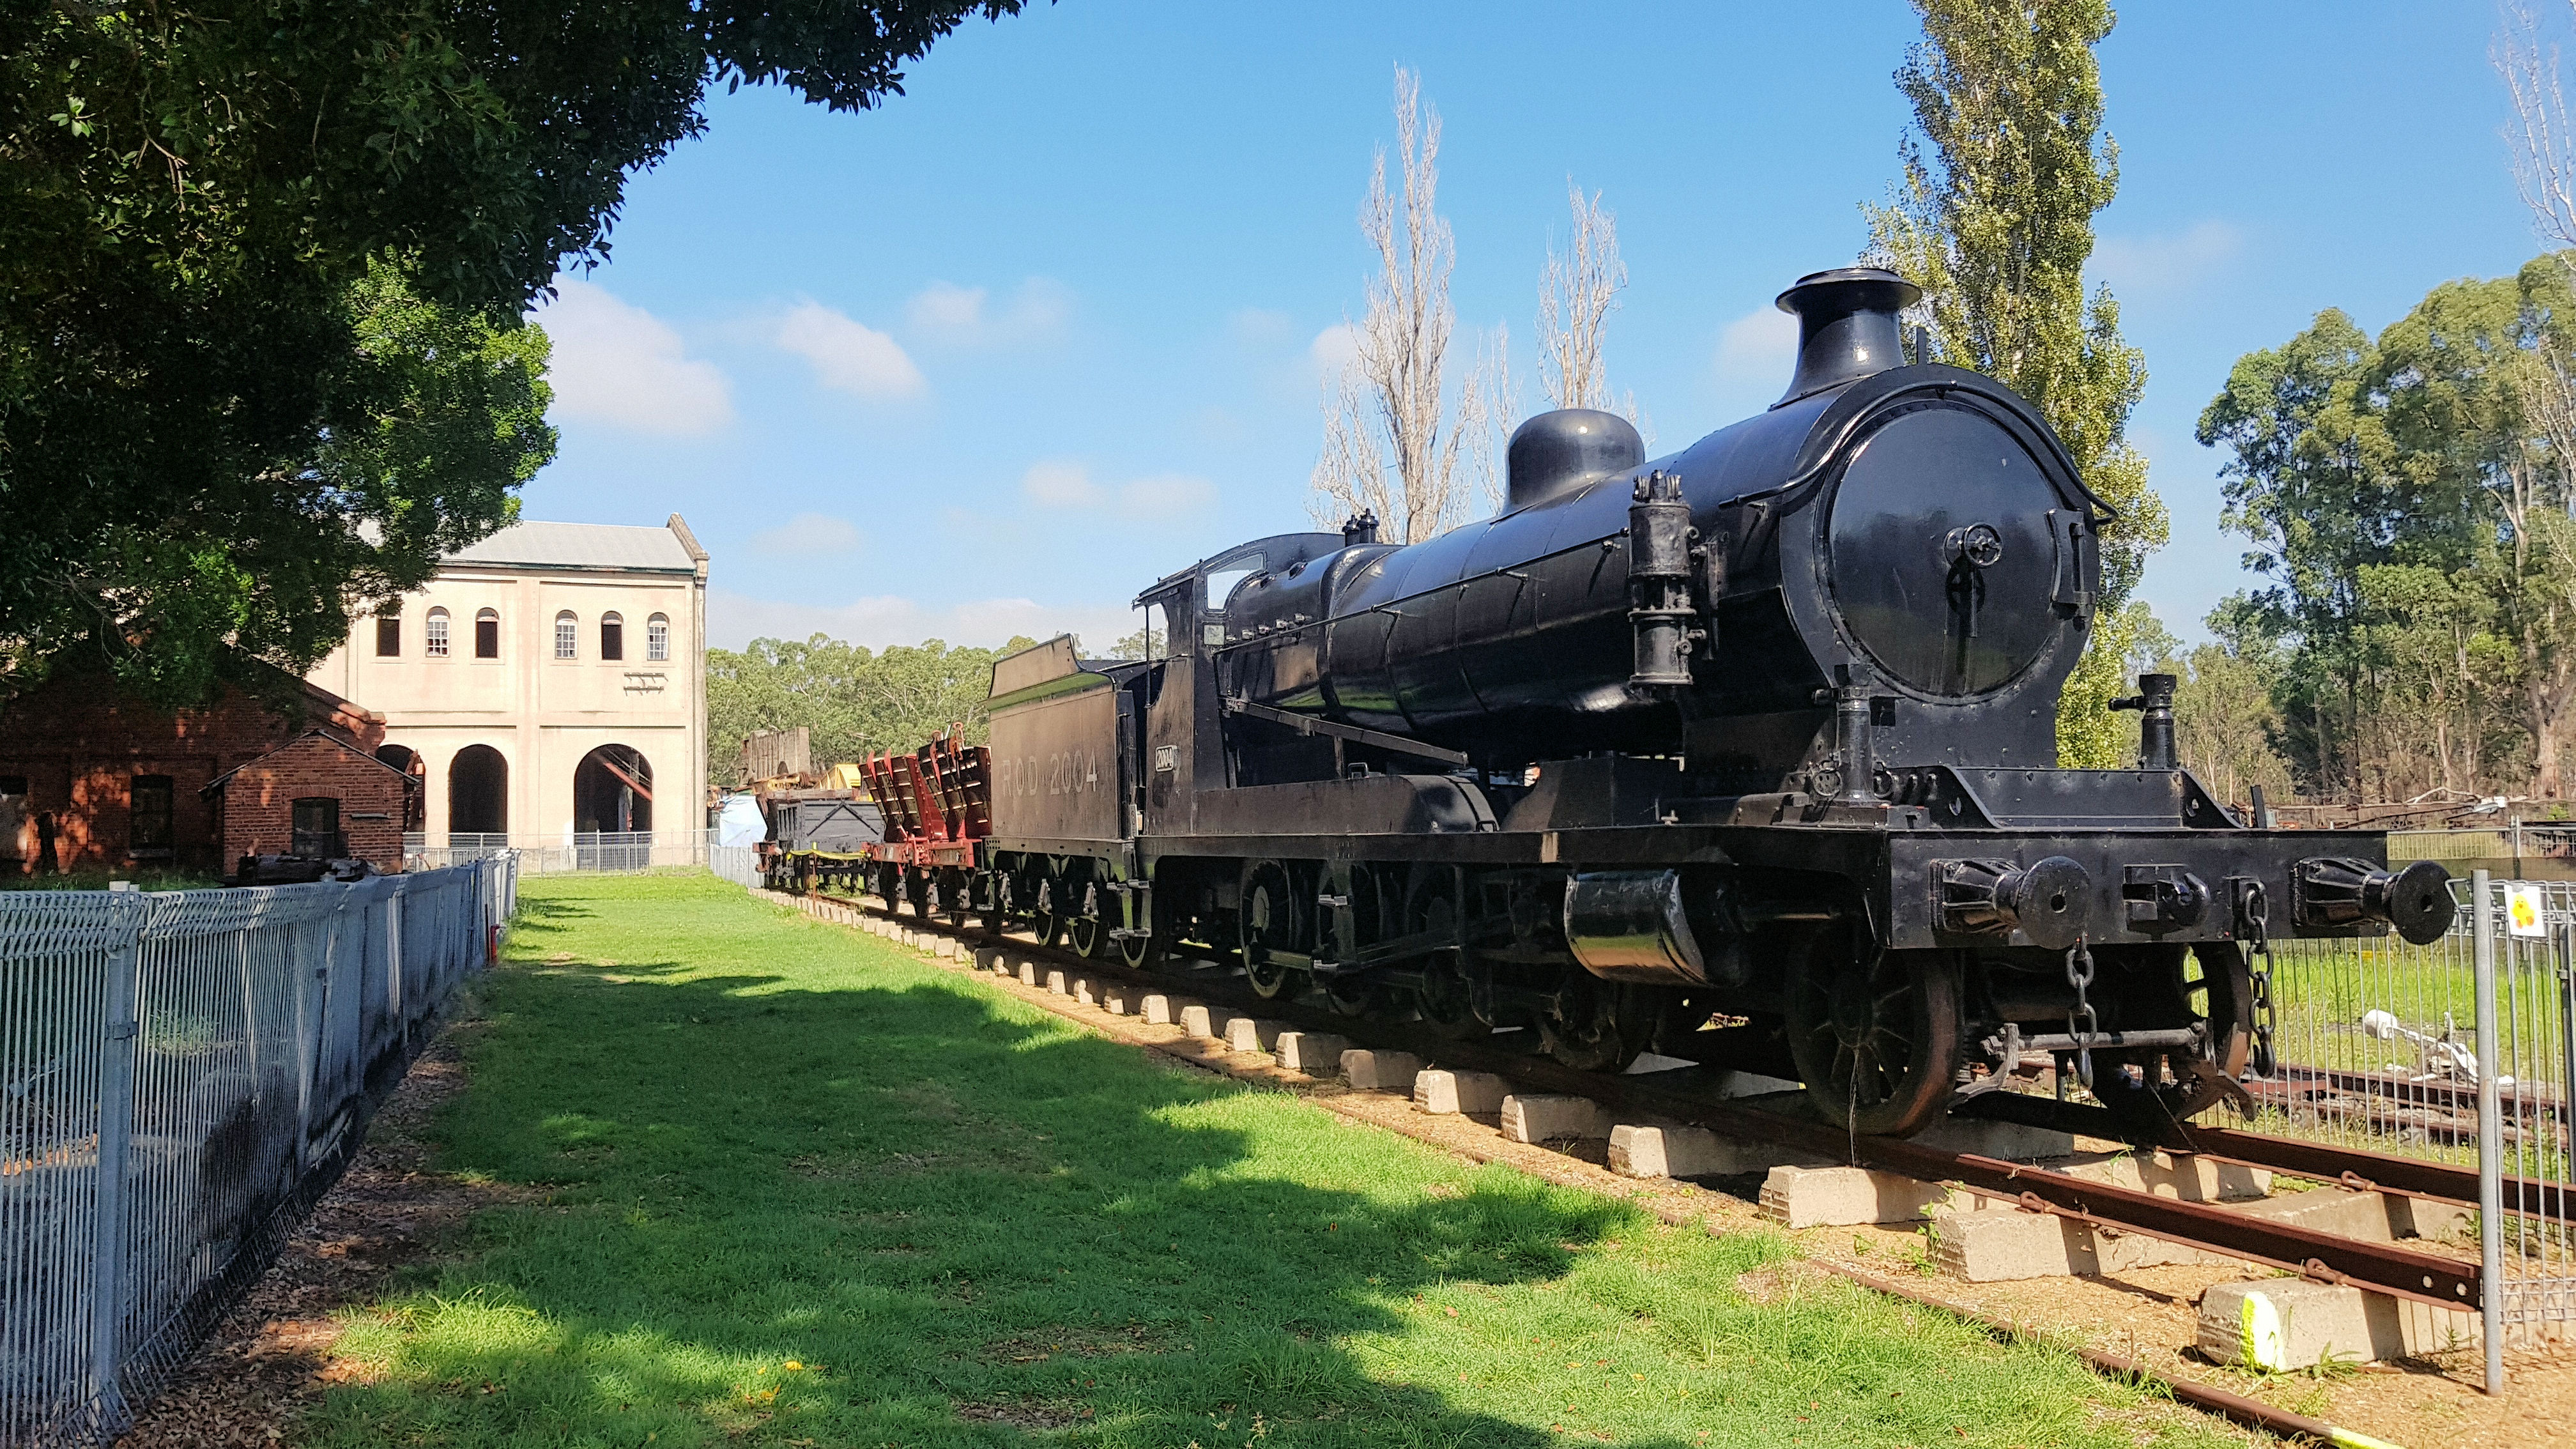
302 877 2236 1449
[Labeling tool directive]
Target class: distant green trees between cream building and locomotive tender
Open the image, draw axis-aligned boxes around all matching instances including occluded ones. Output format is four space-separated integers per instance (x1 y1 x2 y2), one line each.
706 634 1036 781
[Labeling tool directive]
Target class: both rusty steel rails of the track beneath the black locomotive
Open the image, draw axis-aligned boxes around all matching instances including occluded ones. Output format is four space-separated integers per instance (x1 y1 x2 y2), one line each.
781 894 2504 1312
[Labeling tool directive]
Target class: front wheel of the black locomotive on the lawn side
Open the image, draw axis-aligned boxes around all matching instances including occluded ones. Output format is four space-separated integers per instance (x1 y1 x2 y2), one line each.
1788 931 1958 1137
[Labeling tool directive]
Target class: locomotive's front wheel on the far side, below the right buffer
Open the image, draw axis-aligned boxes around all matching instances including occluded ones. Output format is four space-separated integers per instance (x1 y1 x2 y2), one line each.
2092 941 2254 1140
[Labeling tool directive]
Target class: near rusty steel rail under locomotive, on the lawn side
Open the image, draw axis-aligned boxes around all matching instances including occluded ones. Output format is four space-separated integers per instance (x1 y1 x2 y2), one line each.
814 887 2481 1312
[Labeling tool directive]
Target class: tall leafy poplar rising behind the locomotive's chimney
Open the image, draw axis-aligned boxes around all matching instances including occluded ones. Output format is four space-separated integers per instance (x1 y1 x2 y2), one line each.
1865 0 2166 769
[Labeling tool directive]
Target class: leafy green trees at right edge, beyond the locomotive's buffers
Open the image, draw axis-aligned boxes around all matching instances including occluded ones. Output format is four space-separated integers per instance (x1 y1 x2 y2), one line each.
2200 258 2576 797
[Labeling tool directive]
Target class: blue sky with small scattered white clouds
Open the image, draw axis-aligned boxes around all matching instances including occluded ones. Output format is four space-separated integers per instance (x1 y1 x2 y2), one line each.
523 0 2534 647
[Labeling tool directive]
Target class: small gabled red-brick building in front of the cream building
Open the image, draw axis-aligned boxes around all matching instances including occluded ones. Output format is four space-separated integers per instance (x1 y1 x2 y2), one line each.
206 730 412 871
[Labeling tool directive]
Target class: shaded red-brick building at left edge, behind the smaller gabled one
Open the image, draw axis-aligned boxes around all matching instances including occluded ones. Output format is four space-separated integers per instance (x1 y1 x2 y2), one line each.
0 665 402 874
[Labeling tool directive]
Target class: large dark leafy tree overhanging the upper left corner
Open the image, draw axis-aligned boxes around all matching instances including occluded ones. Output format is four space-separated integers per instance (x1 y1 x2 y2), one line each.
0 0 1023 696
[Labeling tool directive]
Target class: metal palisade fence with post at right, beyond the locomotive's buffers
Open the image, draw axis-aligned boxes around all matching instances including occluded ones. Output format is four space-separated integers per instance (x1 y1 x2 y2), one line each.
2246 871 2576 1387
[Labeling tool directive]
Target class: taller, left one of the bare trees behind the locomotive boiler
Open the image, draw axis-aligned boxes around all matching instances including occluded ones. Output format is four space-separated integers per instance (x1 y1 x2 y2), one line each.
1311 67 1489 541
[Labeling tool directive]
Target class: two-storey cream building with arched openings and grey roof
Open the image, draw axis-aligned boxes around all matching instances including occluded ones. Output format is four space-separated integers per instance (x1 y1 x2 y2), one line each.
312 513 706 848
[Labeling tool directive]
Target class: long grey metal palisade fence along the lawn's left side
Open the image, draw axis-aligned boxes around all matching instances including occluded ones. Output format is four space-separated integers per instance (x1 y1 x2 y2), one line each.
0 854 518 1446
